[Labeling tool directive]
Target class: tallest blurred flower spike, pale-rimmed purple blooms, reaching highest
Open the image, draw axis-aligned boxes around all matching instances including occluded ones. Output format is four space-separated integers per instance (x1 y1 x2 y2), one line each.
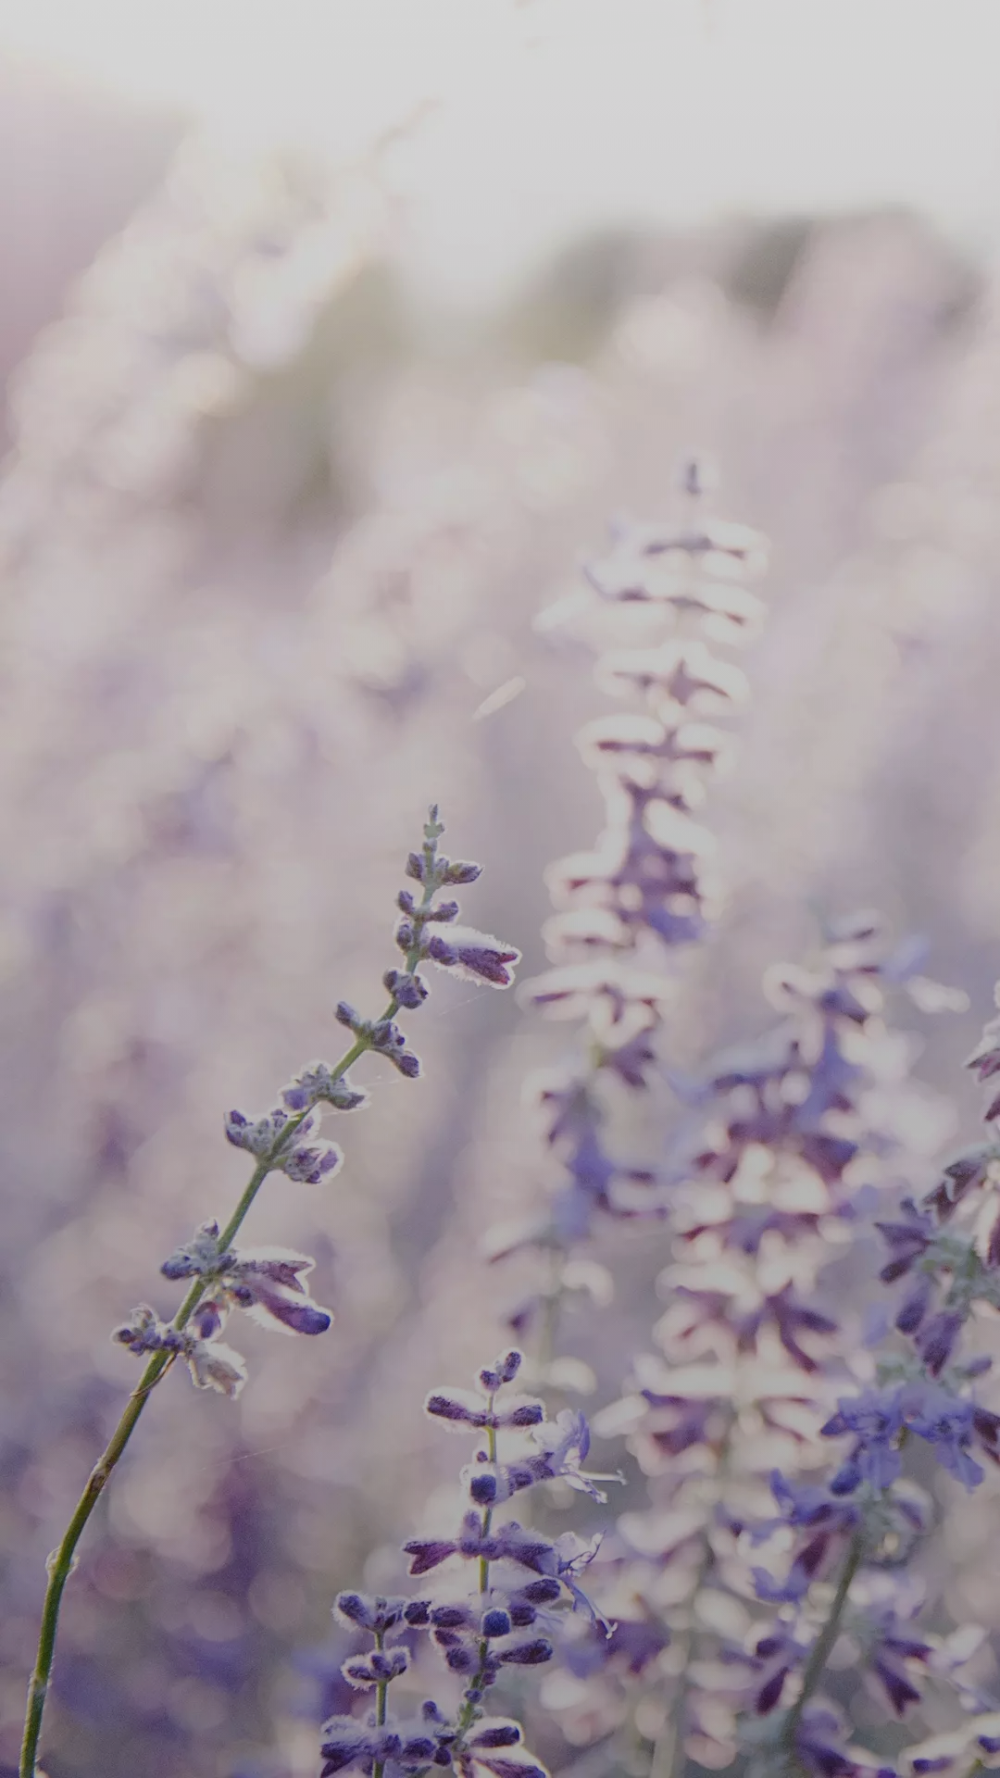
487 469 762 1257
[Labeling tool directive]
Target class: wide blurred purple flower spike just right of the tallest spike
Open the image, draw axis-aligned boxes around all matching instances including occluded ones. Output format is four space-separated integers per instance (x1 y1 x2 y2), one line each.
544 912 996 1771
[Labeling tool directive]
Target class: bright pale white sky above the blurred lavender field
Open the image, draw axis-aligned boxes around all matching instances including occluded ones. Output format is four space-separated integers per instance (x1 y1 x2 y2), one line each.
0 0 1000 299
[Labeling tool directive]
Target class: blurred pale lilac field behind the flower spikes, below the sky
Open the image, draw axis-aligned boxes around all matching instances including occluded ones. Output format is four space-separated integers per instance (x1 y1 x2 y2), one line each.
0 17 1000 1778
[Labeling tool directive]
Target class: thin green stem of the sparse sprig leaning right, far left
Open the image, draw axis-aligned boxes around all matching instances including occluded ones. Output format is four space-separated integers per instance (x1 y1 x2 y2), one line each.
20 867 440 1778
